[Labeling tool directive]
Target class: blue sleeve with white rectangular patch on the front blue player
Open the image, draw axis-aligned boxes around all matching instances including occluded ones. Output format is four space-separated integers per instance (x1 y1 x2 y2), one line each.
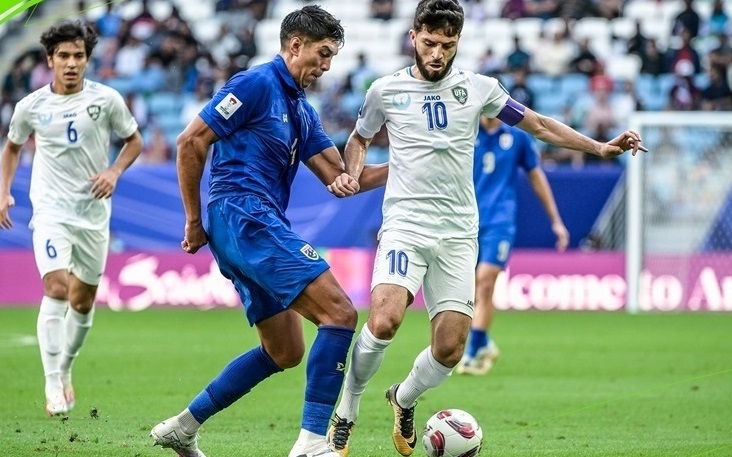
199 72 271 139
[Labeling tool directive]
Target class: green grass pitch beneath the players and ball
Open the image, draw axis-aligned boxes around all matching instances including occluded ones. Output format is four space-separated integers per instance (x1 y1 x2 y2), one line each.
0 308 732 457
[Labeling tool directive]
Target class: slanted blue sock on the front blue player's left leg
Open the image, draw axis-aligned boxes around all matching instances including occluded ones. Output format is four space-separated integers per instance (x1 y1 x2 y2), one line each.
188 346 283 424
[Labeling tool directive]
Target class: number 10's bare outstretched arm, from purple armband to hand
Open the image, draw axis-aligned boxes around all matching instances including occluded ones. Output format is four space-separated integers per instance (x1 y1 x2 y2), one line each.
516 108 648 158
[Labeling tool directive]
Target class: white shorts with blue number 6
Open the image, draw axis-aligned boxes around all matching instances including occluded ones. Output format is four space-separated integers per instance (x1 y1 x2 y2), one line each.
33 224 109 286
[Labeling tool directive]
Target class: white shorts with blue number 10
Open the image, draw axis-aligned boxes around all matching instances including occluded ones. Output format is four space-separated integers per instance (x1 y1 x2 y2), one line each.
371 230 478 320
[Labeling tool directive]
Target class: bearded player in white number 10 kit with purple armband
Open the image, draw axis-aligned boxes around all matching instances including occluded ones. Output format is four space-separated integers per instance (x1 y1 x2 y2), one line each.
329 0 645 456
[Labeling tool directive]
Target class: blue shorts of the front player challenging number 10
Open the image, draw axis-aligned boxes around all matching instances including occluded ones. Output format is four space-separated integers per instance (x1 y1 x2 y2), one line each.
207 196 329 325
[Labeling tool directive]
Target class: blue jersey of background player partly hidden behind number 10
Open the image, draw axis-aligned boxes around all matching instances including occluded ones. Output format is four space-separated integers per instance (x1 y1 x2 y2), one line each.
473 123 539 230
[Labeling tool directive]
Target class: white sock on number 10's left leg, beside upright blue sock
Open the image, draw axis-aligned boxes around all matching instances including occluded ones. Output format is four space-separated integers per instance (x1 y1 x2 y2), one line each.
336 324 391 422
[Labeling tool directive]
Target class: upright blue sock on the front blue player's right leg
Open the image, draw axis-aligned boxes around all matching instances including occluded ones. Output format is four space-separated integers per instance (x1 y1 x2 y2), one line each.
302 325 354 435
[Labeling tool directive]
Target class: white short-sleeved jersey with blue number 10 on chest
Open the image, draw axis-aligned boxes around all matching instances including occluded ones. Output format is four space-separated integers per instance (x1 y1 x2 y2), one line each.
356 67 509 238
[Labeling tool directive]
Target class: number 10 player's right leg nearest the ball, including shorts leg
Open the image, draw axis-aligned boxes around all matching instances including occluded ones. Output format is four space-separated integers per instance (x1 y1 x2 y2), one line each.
386 239 477 455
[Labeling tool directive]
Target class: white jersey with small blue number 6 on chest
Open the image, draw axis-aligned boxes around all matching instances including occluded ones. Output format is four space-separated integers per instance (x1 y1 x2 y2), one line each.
8 80 137 229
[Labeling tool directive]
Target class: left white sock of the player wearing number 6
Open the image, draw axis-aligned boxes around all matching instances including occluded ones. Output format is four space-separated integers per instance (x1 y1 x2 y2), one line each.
36 296 69 386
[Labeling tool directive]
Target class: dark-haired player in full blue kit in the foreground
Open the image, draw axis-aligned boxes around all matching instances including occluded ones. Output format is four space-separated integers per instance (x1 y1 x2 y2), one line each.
151 6 387 457
